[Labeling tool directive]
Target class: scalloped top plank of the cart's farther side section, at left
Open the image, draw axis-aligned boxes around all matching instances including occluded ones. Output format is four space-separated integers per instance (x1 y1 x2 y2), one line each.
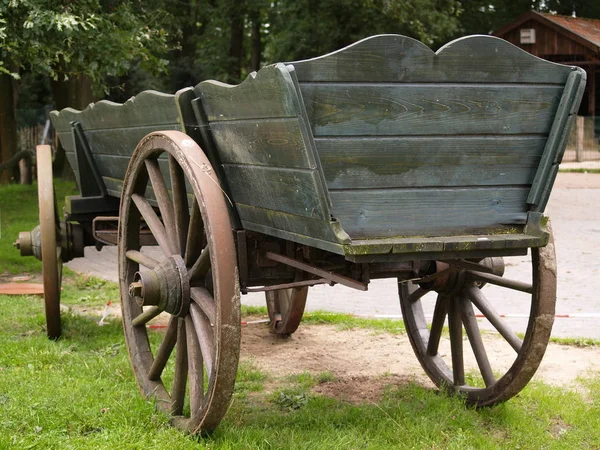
50 91 182 132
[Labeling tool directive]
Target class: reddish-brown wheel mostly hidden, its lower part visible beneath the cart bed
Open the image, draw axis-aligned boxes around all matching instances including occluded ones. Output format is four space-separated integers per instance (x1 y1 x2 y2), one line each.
266 286 308 336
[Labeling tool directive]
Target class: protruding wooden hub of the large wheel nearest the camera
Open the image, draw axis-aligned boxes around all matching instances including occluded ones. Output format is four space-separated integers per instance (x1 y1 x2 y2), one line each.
129 255 190 317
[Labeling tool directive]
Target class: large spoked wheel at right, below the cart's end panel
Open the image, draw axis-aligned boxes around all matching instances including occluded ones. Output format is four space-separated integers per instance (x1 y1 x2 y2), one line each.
399 236 556 406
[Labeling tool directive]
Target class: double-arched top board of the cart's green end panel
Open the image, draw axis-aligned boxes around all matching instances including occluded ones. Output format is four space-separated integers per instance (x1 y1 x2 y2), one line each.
288 35 570 84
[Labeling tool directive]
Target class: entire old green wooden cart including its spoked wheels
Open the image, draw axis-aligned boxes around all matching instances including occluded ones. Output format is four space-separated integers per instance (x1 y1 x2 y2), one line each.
15 35 585 432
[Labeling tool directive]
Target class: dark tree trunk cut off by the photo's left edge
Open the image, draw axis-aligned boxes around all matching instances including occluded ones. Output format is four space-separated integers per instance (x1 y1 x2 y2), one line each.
0 74 19 184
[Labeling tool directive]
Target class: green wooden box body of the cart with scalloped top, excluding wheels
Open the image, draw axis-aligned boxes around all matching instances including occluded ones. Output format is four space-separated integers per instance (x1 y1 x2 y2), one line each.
52 35 585 257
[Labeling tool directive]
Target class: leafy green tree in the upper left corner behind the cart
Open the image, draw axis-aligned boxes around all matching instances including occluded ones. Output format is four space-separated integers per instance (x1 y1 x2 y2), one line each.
0 0 168 182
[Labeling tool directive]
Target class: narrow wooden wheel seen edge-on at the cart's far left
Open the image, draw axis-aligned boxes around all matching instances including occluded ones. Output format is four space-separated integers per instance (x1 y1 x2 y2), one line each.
36 145 62 339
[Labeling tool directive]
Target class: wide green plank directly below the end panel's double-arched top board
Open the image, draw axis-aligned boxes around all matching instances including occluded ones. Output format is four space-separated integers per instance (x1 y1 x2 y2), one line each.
301 83 562 137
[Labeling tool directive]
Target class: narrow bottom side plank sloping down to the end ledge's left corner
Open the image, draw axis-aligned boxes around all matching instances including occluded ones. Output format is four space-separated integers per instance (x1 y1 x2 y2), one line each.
236 203 350 244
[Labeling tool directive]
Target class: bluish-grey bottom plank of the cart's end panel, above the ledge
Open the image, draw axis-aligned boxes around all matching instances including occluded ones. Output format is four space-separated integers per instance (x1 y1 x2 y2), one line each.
330 187 529 239
